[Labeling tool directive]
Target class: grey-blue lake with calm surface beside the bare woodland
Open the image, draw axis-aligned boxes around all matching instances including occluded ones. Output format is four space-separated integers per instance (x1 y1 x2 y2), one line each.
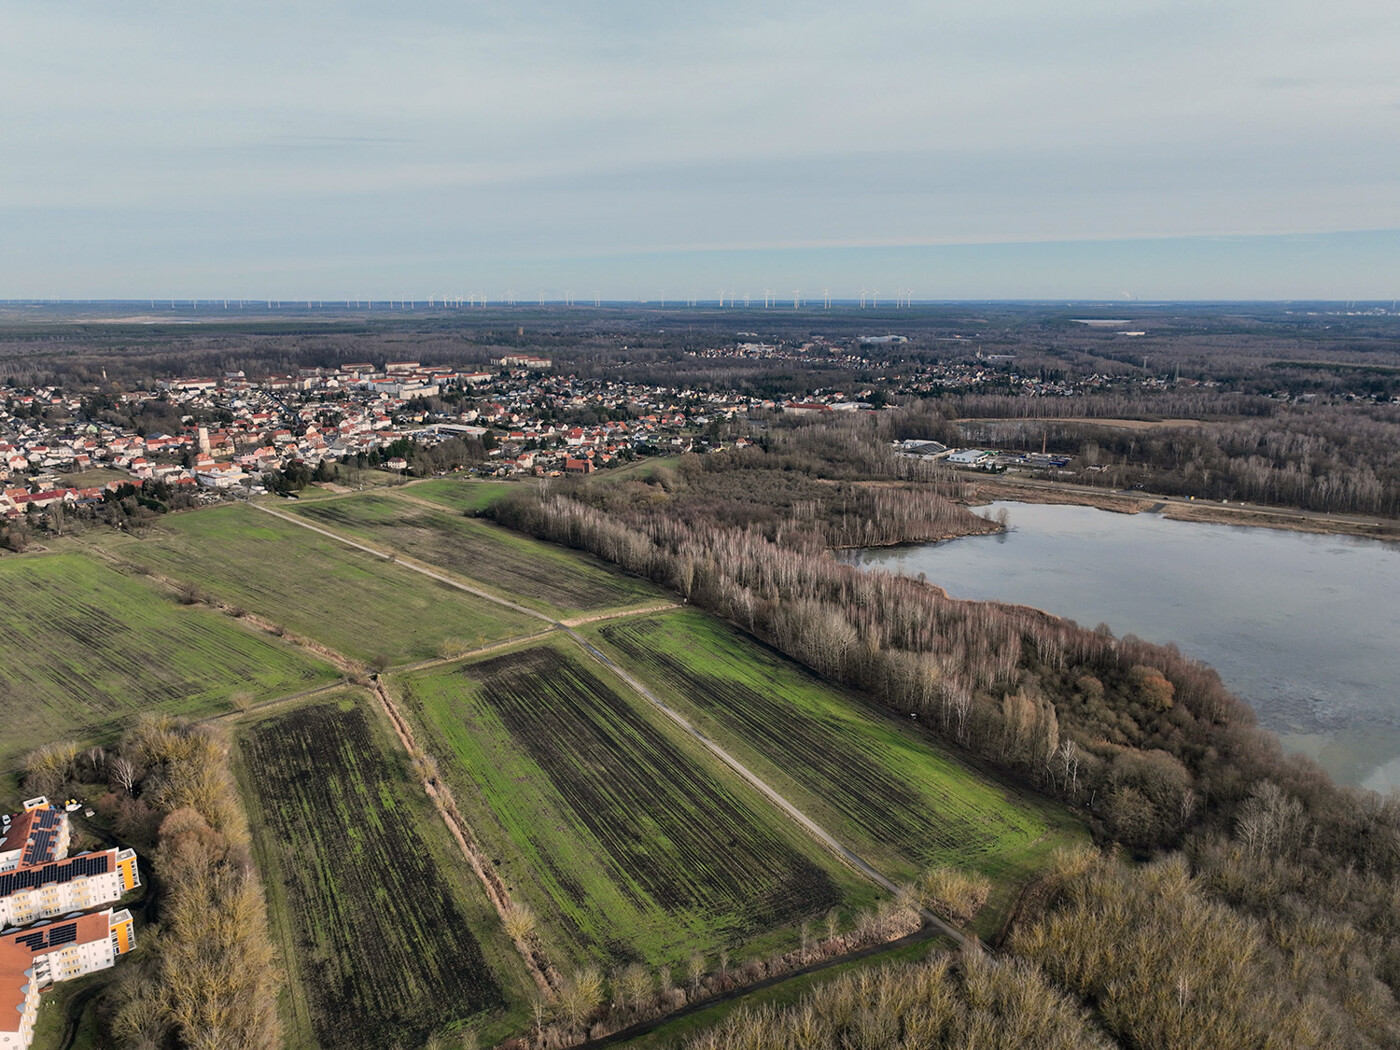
850 503 1400 791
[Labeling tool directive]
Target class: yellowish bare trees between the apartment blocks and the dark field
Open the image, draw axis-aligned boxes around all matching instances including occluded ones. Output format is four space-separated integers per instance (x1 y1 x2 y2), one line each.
25 715 281 1050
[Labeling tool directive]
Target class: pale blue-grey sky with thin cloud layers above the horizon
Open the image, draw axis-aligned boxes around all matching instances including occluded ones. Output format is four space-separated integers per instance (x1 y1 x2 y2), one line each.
0 0 1400 301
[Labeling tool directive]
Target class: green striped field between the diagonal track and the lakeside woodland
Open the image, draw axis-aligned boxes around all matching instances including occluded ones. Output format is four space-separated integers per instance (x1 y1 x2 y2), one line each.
588 610 1082 886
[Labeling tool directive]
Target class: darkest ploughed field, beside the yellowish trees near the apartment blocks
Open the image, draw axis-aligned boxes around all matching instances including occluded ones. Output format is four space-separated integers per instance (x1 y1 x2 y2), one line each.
235 693 528 1050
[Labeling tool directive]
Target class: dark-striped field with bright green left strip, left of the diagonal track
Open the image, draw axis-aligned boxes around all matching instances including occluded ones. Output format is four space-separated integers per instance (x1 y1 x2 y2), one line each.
396 638 875 966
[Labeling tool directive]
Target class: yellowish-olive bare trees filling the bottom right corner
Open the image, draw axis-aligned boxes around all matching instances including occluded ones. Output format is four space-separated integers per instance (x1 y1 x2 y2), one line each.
686 840 1400 1050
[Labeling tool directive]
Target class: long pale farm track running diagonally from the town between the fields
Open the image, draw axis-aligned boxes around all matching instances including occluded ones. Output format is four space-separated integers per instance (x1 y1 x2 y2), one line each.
249 503 974 945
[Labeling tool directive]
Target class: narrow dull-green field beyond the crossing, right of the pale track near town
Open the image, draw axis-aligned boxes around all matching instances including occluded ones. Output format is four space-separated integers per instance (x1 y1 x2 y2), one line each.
294 493 668 616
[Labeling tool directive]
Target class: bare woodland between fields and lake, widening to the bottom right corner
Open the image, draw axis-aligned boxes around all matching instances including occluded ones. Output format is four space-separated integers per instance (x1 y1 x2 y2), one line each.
523 417 1400 1050
